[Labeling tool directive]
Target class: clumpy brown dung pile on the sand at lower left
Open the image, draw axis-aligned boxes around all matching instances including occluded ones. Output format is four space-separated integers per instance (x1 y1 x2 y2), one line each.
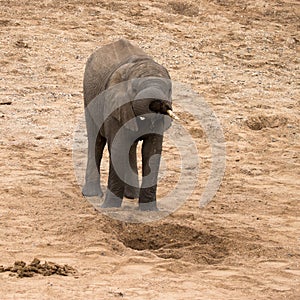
0 258 77 278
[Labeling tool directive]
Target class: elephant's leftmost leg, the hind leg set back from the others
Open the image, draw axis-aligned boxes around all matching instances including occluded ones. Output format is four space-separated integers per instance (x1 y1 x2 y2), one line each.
82 112 106 197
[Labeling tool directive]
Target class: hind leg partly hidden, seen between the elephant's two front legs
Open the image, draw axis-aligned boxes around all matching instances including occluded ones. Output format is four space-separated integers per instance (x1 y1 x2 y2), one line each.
124 142 139 199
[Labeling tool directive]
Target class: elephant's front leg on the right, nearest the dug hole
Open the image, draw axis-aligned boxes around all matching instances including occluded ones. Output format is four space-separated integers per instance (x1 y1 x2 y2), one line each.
139 134 163 210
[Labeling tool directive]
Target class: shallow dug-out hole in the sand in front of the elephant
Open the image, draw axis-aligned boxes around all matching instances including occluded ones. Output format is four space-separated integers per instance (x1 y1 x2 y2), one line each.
119 223 228 264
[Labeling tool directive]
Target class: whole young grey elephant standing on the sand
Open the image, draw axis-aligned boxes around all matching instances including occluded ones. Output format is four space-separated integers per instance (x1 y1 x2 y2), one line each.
82 39 172 210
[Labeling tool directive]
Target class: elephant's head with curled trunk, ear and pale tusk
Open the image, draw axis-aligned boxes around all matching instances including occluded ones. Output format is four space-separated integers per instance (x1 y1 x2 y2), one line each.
105 60 177 131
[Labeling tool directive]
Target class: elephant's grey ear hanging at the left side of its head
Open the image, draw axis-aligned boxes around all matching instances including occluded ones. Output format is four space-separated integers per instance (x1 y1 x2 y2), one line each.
104 81 138 131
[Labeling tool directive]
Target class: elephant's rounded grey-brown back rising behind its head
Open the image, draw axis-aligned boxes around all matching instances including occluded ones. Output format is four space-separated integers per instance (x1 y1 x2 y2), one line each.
83 39 151 106
